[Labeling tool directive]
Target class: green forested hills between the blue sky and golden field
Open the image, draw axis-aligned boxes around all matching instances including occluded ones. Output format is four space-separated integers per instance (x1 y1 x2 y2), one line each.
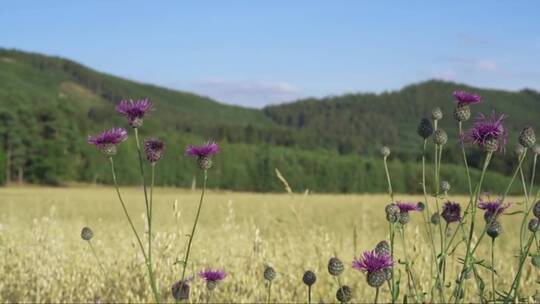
0 49 540 193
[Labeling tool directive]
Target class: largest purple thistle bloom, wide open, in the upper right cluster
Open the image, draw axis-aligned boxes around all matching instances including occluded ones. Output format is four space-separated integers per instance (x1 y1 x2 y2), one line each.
462 112 508 152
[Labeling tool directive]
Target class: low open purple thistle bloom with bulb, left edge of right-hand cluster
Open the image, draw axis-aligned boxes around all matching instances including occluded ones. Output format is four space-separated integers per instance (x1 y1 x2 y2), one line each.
352 250 394 288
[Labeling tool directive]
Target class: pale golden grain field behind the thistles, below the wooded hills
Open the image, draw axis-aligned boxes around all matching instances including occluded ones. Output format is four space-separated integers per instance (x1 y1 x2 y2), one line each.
0 187 540 303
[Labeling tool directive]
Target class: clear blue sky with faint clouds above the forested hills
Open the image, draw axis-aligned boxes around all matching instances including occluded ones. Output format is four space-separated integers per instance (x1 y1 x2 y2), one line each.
0 0 540 107
